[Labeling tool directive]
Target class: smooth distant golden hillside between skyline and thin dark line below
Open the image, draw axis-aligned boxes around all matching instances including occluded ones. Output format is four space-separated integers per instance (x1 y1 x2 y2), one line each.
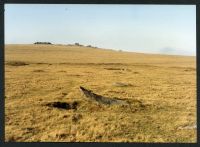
5 45 196 67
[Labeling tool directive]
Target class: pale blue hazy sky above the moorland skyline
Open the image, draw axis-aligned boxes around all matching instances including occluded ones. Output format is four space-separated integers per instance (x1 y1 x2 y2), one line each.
5 4 196 56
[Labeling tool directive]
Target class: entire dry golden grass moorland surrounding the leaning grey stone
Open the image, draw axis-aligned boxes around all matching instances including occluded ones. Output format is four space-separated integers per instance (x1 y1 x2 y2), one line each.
5 45 197 142
